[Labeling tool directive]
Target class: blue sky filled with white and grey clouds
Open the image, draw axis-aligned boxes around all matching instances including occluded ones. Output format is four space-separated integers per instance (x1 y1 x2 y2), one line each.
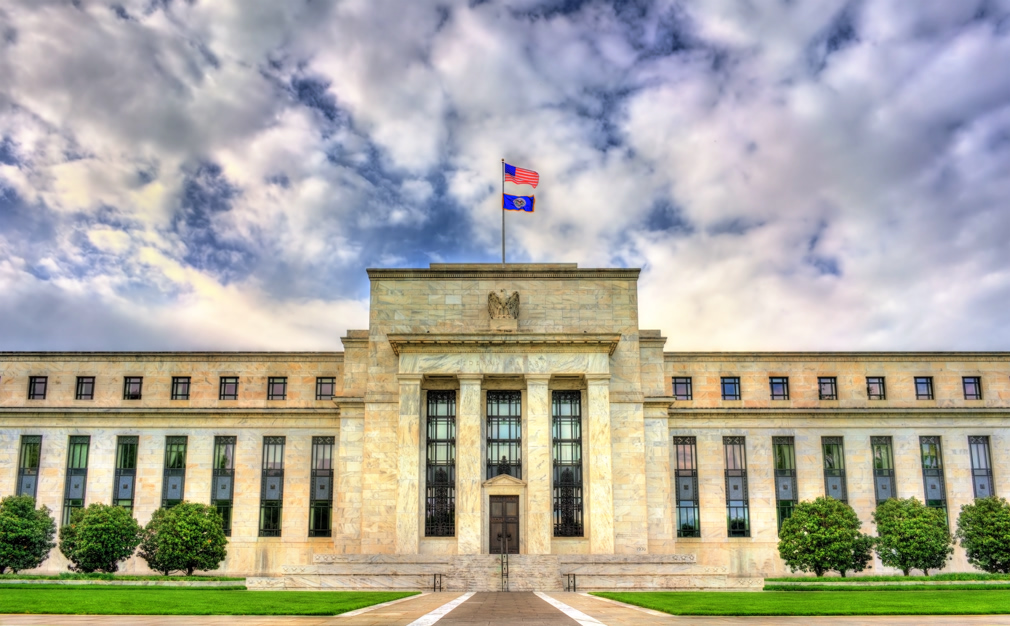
0 0 1010 350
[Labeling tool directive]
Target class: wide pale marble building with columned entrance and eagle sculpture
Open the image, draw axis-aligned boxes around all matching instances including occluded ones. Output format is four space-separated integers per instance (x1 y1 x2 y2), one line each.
0 264 1010 590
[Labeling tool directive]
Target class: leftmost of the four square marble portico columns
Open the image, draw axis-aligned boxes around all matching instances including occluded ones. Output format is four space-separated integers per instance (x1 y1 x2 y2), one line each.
396 374 421 554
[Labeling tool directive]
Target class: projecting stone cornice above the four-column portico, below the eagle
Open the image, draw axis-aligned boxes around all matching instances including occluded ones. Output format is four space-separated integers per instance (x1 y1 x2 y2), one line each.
386 332 621 355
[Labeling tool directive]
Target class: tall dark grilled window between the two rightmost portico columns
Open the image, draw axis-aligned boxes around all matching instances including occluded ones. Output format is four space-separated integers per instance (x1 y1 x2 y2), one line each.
550 391 584 537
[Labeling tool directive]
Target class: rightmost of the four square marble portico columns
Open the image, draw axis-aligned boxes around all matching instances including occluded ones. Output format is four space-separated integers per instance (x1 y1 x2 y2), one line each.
583 374 614 554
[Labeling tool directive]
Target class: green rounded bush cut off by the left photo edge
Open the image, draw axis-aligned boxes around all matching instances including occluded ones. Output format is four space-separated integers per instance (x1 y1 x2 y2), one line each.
0 496 57 573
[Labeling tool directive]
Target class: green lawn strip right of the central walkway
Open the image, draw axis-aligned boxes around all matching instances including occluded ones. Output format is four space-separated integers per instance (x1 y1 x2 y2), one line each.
592 589 1010 615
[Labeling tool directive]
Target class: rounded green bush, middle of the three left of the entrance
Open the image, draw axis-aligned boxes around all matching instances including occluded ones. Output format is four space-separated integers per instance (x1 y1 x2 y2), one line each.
60 503 141 573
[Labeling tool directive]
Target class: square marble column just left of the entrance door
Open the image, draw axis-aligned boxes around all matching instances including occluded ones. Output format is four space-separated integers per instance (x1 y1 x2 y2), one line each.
456 374 484 554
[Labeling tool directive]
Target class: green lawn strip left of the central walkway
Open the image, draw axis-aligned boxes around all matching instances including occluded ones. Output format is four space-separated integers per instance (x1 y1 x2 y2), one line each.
0 585 417 615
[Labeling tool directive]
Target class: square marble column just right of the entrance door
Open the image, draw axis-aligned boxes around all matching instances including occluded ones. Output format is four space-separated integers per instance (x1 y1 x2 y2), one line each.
523 374 552 554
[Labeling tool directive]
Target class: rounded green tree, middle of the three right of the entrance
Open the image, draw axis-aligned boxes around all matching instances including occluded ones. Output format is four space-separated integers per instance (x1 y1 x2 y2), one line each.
874 498 953 576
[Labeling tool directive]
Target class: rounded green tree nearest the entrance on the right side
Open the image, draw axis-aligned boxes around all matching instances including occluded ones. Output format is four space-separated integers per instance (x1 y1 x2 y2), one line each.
779 497 874 577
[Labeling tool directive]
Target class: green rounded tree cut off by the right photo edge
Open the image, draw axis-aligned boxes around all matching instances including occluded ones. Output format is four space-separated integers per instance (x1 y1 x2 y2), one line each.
954 497 1010 573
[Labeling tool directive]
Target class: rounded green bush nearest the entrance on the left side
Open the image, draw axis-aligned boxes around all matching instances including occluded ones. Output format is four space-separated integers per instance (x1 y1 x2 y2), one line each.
139 502 228 576
